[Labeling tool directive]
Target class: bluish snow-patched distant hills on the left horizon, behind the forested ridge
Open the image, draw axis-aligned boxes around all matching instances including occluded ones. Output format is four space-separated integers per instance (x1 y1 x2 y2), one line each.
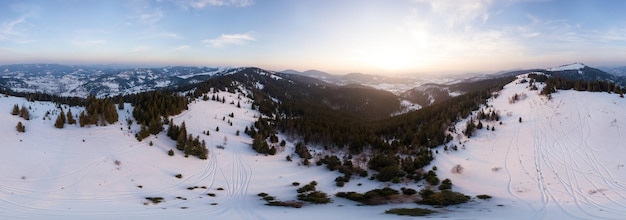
0 64 241 97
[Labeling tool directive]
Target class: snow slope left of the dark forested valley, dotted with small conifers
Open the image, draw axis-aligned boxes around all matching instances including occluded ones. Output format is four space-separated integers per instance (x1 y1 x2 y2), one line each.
0 92 411 219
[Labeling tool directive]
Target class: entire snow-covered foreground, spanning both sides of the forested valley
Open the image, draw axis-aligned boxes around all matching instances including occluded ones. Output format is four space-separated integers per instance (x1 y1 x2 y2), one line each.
0 74 626 219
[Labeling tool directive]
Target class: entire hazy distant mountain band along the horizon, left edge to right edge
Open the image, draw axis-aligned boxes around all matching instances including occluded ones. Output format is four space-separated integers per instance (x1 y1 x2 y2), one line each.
0 63 626 106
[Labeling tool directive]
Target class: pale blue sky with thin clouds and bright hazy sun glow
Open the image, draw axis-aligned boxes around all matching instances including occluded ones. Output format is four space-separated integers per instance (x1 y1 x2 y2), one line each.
0 0 626 74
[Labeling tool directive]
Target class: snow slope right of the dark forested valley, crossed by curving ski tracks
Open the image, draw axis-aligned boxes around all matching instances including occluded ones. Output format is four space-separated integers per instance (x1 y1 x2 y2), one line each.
434 75 626 219
